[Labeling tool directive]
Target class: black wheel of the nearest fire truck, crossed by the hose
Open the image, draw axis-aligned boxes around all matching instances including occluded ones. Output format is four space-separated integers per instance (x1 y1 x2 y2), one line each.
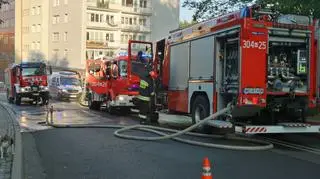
191 95 212 134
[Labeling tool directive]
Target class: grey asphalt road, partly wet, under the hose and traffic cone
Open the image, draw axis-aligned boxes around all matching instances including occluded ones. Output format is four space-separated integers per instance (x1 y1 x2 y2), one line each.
0 94 320 179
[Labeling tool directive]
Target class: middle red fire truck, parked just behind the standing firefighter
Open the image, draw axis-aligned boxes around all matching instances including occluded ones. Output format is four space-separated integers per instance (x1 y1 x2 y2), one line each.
86 40 152 114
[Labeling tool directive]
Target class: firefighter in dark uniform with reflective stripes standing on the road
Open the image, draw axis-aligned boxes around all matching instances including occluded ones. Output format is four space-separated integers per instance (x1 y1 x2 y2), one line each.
137 60 159 124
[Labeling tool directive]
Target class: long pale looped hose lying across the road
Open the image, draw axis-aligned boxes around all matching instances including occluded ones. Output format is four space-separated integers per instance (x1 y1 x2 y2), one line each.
48 105 273 151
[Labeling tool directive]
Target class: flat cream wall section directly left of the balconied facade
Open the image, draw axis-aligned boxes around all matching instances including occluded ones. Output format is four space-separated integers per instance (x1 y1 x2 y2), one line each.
48 0 85 69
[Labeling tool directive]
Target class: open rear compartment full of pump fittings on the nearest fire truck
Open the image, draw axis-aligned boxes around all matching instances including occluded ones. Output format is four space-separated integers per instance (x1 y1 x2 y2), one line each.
267 38 310 93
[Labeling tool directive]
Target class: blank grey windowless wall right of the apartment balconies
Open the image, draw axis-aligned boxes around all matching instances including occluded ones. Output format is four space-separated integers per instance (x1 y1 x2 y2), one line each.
151 0 180 41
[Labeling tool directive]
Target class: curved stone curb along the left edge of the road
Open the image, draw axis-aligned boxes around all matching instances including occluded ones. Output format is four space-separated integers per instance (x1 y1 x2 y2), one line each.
0 102 23 179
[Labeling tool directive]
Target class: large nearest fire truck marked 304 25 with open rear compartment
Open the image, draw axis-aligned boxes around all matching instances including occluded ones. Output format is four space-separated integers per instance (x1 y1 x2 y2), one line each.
154 5 320 134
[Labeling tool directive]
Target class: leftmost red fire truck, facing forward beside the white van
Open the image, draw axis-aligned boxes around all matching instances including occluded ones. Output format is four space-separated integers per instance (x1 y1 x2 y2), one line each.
5 62 49 105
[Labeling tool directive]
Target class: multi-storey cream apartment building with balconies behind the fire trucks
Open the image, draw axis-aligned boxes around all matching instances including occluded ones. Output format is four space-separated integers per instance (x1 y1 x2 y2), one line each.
6 0 180 69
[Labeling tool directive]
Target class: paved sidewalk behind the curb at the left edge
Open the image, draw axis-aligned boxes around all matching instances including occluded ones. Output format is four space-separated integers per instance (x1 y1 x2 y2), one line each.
0 106 14 179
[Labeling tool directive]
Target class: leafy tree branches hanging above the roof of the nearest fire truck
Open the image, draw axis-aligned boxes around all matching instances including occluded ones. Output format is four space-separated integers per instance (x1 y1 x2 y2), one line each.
182 0 320 21
